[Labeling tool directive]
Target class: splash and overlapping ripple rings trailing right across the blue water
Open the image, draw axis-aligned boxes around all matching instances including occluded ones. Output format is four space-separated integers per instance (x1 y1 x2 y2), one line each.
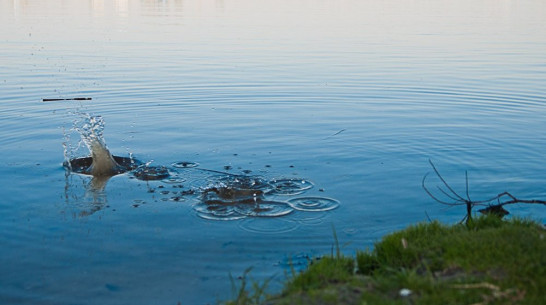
64 113 339 221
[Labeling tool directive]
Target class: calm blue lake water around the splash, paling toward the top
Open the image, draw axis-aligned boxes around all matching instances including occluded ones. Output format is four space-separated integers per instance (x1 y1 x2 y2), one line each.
0 0 546 304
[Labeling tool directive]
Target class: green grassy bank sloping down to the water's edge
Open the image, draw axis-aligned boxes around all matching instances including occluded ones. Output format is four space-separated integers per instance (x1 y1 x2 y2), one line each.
223 216 546 305
